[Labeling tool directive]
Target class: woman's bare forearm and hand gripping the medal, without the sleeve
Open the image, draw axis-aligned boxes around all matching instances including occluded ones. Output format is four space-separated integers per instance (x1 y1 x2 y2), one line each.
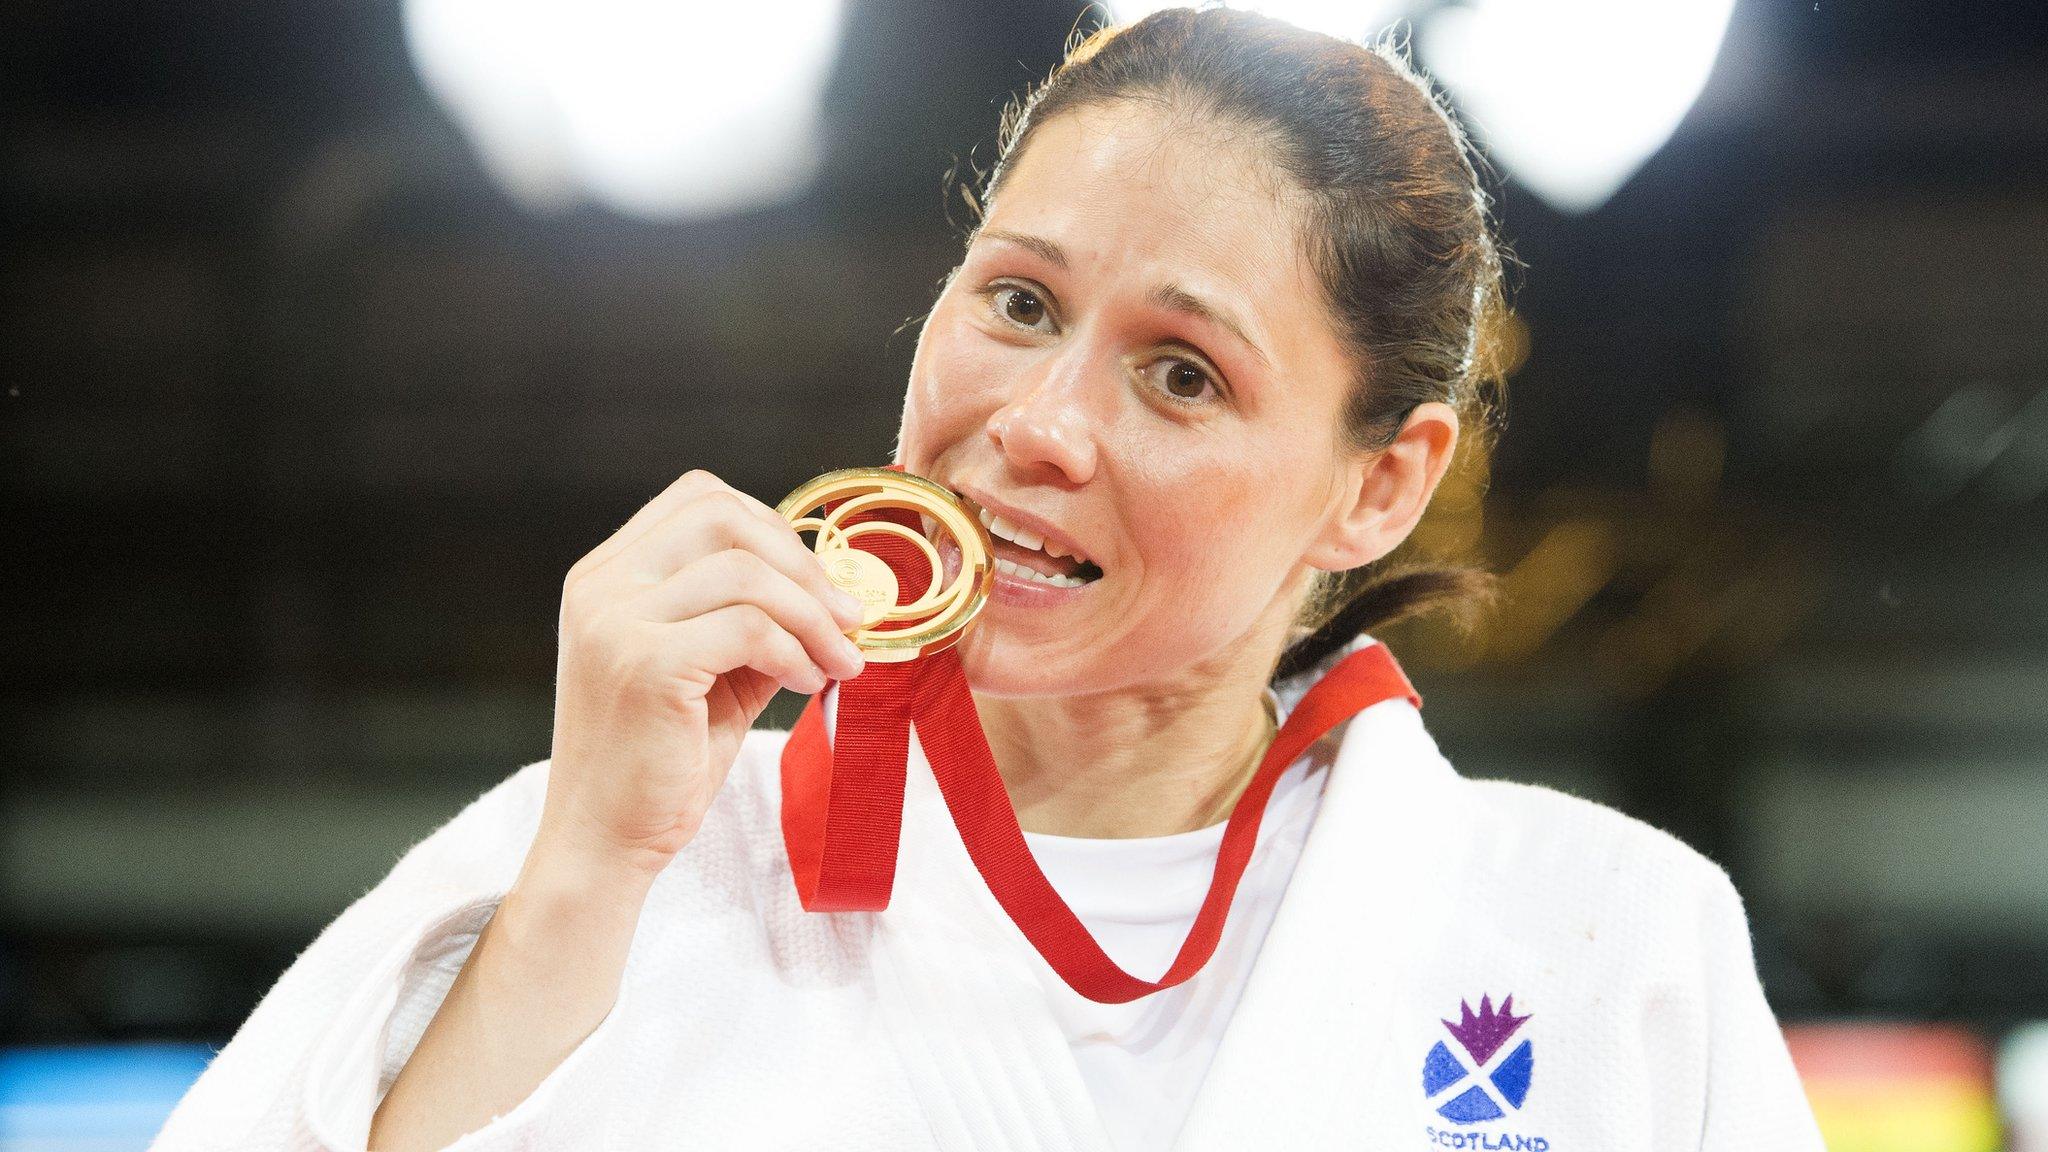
369 471 866 1152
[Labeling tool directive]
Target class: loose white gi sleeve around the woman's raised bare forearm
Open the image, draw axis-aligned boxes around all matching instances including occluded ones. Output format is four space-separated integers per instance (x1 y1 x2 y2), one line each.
150 760 625 1152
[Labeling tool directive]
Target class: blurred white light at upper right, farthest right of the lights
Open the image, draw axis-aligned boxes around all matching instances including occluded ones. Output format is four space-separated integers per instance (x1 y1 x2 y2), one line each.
1421 0 1735 213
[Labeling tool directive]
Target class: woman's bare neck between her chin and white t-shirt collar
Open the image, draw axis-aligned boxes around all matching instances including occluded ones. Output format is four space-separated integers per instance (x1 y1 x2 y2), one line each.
975 637 1278 838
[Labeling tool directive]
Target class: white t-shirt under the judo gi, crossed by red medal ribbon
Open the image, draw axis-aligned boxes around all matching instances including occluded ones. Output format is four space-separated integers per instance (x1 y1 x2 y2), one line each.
1024 689 1329 1152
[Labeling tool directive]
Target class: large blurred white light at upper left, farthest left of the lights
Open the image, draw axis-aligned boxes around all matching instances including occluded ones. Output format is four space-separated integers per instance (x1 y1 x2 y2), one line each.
403 0 842 217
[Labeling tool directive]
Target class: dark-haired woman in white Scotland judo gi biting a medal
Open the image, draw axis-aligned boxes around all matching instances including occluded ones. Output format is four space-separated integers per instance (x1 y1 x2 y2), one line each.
158 10 1819 1152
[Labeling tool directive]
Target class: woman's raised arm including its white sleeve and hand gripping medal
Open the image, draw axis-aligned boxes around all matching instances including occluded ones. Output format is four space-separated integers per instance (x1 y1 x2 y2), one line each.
156 471 864 1152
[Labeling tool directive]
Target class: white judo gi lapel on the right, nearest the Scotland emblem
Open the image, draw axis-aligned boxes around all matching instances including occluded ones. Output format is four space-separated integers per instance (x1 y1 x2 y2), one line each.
1174 684 1468 1152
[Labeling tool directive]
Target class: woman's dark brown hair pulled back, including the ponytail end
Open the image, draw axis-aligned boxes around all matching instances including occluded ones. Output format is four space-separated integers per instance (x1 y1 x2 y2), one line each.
969 8 1507 678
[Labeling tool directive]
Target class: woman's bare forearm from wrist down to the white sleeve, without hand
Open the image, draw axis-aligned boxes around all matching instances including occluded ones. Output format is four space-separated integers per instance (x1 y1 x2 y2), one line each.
371 851 651 1152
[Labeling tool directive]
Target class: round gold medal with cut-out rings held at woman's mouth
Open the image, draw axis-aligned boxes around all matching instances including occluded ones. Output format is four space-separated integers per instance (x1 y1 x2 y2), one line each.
776 467 995 662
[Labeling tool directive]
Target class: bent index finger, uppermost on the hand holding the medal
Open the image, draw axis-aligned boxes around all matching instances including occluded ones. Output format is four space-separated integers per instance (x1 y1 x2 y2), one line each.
608 490 860 631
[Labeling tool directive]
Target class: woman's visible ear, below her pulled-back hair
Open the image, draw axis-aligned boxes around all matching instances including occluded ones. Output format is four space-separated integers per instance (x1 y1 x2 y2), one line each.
1303 400 1458 572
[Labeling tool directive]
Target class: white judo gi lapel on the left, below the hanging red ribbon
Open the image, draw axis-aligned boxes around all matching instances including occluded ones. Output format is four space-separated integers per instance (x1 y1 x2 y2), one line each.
874 701 1112 1152
